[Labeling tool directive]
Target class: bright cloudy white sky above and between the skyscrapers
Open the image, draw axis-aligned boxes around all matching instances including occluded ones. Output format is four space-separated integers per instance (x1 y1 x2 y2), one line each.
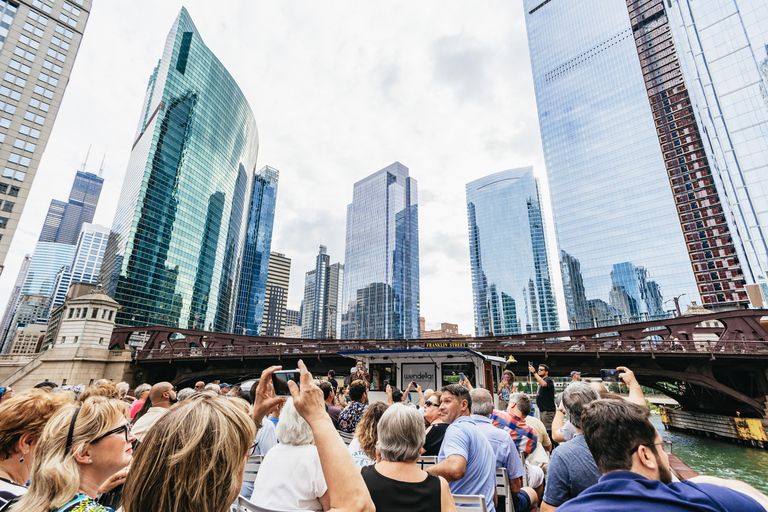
0 0 557 334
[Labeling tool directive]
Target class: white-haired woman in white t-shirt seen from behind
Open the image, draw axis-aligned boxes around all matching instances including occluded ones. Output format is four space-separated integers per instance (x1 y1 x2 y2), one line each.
250 398 330 510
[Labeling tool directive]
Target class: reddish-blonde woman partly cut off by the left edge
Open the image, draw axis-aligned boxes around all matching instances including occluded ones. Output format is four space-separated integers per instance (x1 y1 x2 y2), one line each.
0 389 71 506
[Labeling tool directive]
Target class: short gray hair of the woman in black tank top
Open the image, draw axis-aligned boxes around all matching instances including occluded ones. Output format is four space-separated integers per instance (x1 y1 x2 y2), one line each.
378 404 426 462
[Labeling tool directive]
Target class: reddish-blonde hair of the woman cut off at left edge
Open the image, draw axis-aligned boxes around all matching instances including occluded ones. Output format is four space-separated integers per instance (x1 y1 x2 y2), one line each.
0 389 74 460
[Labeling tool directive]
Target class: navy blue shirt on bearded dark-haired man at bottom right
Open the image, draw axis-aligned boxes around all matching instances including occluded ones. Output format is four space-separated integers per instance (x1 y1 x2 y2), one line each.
557 472 764 512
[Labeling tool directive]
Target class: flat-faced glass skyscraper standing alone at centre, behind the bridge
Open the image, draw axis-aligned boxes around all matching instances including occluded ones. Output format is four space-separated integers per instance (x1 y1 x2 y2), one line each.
342 162 419 339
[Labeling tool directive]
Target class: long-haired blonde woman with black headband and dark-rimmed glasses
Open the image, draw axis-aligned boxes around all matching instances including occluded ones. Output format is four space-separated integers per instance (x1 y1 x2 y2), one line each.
11 396 136 512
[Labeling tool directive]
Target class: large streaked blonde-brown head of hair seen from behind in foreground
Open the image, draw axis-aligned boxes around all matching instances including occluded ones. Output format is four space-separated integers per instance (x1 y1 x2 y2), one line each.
123 393 256 512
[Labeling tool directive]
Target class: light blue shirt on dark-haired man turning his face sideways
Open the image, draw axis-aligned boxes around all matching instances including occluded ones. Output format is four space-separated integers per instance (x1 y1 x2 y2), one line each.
437 416 496 512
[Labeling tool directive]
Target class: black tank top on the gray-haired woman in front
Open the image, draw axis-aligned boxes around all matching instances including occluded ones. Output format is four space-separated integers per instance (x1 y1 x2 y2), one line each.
361 466 441 512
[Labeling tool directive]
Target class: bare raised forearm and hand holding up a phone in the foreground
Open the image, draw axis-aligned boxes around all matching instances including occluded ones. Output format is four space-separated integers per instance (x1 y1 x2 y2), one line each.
288 361 375 512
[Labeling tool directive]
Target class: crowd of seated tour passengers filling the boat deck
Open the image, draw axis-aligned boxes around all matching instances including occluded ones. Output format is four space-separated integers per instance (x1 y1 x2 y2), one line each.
0 361 768 512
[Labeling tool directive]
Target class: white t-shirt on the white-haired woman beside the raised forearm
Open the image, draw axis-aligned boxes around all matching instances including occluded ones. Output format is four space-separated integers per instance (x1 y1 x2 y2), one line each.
250 443 328 512
